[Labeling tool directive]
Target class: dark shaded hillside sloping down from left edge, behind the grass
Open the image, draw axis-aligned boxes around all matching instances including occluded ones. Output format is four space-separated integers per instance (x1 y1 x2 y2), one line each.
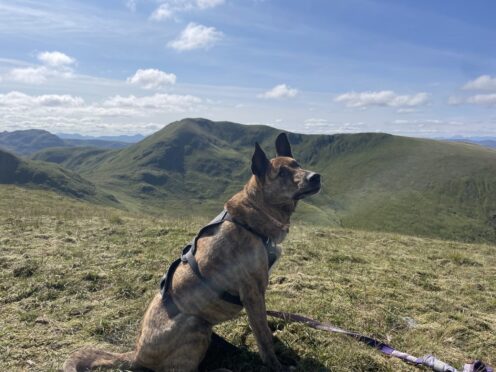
0 150 118 205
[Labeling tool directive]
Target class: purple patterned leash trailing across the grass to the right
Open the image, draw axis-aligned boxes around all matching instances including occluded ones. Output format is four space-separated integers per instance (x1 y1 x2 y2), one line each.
267 310 494 372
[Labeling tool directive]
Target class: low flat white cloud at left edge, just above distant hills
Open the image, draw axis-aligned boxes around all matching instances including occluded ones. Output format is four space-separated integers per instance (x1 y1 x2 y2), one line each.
0 91 84 108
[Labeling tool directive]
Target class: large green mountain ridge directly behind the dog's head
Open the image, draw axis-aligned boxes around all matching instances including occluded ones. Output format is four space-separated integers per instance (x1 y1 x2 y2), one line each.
37 119 496 242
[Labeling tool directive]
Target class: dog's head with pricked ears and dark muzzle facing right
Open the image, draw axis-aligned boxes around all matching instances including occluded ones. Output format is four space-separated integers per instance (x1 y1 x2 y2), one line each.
251 133 321 206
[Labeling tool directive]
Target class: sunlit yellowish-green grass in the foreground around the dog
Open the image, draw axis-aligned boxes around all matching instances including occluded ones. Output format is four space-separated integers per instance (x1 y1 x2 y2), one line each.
0 186 496 371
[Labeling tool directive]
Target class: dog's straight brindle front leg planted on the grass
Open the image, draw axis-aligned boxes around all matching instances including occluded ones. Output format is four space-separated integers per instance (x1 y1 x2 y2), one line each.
243 290 283 371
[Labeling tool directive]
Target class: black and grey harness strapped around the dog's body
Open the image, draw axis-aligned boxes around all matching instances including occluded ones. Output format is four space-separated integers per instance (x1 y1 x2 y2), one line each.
160 209 277 318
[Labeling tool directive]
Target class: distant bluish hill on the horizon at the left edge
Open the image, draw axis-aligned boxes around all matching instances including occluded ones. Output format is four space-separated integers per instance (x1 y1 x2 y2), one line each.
0 129 129 156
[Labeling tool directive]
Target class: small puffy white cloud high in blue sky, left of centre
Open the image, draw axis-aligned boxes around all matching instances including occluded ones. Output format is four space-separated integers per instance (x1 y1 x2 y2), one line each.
167 23 223 51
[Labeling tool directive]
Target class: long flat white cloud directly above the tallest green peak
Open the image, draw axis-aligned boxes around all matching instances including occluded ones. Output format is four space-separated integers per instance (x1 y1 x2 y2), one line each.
103 93 202 112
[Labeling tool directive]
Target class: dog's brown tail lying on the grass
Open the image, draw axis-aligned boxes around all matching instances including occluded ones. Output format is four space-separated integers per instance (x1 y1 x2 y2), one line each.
62 348 139 372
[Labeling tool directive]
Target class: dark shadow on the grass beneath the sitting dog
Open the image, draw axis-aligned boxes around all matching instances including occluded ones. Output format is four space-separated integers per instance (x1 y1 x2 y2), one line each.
199 333 330 372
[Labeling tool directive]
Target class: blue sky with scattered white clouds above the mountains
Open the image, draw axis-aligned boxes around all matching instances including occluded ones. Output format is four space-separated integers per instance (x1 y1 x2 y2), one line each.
0 0 496 138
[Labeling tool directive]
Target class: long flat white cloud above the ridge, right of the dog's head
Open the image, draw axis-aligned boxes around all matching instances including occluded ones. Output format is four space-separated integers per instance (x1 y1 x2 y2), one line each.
334 90 429 108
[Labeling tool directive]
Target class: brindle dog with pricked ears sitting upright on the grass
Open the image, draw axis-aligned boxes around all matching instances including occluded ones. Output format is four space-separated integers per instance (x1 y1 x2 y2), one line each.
63 133 321 372
